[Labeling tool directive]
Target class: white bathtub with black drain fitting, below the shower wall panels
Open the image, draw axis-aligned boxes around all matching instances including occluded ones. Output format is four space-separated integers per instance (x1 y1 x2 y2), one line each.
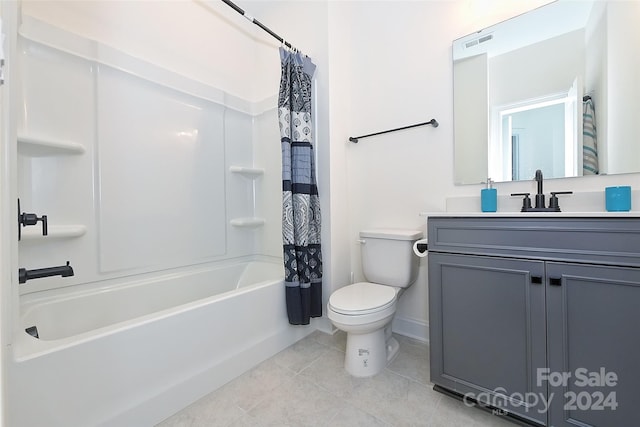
7 261 311 427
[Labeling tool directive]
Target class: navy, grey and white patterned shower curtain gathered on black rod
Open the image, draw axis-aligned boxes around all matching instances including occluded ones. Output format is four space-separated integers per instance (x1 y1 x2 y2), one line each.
278 48 322 325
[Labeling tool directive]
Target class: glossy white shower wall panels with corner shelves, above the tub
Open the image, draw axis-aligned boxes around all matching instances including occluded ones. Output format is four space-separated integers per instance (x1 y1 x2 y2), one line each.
16 16 281 295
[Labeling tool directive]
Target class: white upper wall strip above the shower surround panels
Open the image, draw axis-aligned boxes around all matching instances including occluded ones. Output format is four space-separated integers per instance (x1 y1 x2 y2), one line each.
22 0 268 101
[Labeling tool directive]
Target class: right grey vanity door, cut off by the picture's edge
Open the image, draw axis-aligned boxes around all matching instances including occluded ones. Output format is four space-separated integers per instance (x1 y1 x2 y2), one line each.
544 262 640 427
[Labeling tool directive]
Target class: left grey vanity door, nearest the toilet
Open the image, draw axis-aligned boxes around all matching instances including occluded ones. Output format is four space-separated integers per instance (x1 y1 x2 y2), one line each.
429 253 547 423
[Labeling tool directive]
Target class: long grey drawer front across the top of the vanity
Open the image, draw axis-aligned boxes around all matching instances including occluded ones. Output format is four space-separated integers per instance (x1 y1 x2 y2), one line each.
427 217 640 266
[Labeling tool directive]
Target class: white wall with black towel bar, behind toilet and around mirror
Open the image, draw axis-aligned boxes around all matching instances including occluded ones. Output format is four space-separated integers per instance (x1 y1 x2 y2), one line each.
319 0 640 342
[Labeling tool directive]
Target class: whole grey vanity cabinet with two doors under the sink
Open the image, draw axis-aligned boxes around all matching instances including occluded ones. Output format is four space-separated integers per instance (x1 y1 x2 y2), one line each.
428 217 640 427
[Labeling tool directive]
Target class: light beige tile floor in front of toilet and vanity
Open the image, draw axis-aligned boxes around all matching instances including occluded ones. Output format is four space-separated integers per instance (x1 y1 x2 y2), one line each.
158 331 515 427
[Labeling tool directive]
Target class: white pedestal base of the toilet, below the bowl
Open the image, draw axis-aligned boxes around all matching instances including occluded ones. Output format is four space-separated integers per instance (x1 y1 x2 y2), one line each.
344 328 400 377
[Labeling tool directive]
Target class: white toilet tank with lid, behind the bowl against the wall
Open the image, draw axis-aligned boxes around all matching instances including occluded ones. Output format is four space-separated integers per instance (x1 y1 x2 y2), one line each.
360 229 422 288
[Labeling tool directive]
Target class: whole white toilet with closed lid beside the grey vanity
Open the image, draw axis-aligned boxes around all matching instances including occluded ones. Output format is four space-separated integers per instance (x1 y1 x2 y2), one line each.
327 229 422 377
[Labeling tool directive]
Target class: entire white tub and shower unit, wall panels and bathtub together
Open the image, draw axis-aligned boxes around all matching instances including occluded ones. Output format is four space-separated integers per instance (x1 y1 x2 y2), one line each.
7 10 298 427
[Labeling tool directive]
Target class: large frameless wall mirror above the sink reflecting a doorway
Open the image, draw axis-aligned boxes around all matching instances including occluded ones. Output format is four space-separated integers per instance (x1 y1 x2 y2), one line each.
453 0 640 184
